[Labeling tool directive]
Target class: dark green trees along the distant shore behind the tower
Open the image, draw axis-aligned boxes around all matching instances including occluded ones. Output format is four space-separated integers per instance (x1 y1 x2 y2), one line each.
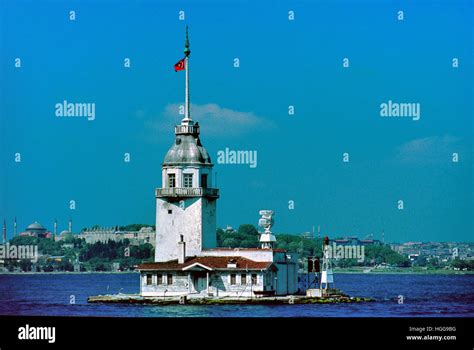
5 224 474 272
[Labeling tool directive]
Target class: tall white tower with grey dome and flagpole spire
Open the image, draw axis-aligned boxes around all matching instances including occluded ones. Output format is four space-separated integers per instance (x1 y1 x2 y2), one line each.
155 28 219 262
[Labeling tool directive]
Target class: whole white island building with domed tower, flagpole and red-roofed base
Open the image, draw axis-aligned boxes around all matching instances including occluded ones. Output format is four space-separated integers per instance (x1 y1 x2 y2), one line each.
138 30 298 297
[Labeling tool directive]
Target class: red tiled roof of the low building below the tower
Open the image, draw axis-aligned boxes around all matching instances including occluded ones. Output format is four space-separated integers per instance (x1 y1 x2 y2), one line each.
138 256 274 271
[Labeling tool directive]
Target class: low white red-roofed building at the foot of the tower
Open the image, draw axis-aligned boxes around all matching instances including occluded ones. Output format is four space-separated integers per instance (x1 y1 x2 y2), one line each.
140 248 298 297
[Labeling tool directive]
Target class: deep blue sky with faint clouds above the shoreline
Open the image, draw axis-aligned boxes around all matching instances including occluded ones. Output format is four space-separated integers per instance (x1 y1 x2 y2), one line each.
0 0 474 241
